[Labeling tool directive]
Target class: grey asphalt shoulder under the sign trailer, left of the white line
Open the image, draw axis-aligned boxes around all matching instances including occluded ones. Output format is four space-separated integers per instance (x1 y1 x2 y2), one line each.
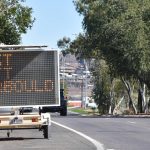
0 116 96 150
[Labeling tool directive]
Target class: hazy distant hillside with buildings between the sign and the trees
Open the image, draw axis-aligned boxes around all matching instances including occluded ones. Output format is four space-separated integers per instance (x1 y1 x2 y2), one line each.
60 54 92 99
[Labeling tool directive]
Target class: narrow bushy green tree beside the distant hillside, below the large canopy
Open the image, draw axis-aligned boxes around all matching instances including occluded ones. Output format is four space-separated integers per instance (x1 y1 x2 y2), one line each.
92 60 110 114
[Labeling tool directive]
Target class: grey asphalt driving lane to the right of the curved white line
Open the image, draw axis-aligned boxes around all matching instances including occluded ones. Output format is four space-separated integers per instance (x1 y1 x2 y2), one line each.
53 113 150 150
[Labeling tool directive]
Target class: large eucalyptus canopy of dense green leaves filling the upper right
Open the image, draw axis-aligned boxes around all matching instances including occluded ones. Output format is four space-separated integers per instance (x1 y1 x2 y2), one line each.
74 0 150 112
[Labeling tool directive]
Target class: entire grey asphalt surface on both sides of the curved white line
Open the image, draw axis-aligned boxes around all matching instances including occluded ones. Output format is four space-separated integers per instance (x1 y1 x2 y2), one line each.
0 114 150 150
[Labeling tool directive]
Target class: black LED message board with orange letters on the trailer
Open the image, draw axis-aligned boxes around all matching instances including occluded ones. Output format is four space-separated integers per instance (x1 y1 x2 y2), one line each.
0 50 59 106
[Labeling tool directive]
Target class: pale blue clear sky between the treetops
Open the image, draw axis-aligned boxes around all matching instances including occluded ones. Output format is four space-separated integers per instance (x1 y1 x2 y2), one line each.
22 0 82 48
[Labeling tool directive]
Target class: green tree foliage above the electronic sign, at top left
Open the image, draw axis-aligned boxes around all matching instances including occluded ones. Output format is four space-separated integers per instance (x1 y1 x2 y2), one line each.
0 0 35 44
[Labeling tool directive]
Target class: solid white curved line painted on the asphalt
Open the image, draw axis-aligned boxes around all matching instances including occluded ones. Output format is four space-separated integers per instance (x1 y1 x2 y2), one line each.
52 121 104 150
